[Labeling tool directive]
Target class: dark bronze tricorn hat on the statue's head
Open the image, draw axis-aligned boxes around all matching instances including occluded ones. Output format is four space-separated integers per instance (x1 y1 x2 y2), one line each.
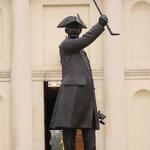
57 14 87 28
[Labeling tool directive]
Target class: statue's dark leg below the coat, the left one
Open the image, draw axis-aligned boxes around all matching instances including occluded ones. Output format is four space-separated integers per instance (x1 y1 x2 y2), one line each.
63 128 76 150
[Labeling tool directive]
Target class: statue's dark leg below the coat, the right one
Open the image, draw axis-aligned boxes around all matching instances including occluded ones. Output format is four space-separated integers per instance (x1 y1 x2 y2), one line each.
82 129 96 150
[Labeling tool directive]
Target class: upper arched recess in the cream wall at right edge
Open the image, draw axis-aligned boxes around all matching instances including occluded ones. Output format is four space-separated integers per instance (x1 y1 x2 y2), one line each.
130 1 150 58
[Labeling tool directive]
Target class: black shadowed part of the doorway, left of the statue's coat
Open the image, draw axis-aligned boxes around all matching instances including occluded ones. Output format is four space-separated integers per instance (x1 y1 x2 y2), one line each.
44 81 59 150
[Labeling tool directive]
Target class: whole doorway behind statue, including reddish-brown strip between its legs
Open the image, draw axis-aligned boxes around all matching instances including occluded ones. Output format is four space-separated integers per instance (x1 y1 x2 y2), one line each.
44 81 84 150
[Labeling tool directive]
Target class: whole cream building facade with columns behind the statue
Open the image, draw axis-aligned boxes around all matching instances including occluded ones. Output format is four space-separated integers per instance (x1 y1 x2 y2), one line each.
0 0 150 150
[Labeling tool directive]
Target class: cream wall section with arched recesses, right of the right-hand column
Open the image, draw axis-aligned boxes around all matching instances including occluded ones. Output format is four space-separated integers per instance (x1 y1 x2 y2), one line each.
124 1 150 150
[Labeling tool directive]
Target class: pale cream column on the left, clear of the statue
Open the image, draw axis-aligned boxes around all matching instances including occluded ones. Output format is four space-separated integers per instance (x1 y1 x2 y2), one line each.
11 0 33 150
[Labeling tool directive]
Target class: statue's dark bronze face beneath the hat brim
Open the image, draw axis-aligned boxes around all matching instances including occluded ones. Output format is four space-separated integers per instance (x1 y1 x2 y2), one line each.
65 24 82 39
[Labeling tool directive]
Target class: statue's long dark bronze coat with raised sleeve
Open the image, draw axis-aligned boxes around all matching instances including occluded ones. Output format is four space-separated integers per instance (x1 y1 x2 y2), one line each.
50 23 104 129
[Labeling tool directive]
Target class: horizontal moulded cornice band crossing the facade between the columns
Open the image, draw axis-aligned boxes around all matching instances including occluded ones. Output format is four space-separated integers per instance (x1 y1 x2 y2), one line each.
0 69 150 82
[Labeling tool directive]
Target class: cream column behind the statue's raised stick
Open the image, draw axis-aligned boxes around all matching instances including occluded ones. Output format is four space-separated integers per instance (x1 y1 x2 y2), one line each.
103 0 127 150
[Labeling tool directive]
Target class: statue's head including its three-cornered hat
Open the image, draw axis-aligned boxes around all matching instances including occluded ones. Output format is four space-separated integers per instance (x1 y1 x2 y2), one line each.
57 15 87 38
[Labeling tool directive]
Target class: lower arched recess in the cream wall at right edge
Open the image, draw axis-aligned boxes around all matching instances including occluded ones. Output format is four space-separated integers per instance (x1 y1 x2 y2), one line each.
132 90 150 150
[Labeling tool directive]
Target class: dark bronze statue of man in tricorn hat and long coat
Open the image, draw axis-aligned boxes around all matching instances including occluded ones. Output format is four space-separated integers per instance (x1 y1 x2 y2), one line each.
50 15 108 150
